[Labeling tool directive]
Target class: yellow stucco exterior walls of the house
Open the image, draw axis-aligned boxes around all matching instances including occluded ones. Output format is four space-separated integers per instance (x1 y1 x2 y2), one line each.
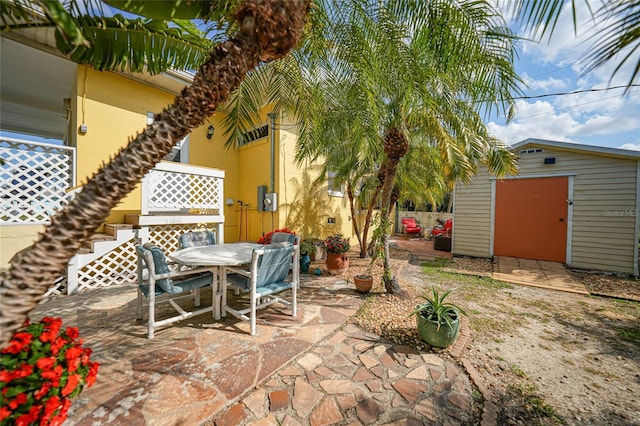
1 66 355 265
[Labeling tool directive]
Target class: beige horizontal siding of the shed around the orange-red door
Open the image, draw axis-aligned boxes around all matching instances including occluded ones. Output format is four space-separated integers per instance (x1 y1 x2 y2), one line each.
453 140 638 273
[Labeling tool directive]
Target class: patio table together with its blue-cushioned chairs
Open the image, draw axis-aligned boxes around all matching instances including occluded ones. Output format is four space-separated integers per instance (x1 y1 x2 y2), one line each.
136 230 300 339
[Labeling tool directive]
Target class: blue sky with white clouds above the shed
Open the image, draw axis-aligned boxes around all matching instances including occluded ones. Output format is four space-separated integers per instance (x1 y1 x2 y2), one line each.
487 0 640 151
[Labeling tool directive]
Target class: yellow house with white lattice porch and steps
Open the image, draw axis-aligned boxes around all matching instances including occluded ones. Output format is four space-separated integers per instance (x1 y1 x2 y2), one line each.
0 33 353 292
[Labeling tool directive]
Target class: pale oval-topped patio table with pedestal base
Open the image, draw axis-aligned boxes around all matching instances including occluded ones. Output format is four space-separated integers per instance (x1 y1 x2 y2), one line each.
169 242 262 319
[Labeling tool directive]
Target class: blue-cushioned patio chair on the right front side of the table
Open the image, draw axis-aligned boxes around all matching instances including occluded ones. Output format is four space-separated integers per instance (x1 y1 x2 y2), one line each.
222 242 300 336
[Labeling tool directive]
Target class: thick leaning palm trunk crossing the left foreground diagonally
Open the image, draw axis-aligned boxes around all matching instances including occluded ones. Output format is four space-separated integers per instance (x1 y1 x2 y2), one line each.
0 0 310 347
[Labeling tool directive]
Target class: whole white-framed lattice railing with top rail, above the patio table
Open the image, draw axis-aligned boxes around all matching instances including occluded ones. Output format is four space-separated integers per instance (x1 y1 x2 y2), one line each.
142 161 224 215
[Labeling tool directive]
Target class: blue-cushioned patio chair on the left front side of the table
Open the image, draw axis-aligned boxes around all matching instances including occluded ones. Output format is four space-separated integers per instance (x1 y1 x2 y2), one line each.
136 243 218 339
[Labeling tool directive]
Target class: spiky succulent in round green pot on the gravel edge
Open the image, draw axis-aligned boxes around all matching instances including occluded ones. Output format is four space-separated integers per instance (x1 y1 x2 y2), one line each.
411 287 467 348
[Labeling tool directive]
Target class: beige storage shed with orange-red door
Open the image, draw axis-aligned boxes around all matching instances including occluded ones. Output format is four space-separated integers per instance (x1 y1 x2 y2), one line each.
452 139 640 276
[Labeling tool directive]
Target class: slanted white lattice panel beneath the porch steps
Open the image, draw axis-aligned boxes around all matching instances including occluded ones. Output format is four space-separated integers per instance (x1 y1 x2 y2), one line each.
78 239 138 291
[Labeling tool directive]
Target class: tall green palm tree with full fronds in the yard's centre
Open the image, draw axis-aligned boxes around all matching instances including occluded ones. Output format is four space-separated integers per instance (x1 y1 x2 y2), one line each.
301 0 519 294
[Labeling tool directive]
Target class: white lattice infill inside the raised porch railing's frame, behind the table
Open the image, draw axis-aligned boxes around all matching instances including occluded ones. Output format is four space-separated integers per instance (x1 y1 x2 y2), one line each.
149 170 223 211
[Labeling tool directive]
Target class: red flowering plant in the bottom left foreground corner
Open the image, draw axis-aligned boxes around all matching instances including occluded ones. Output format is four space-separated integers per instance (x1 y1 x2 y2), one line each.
0 317 99 426
